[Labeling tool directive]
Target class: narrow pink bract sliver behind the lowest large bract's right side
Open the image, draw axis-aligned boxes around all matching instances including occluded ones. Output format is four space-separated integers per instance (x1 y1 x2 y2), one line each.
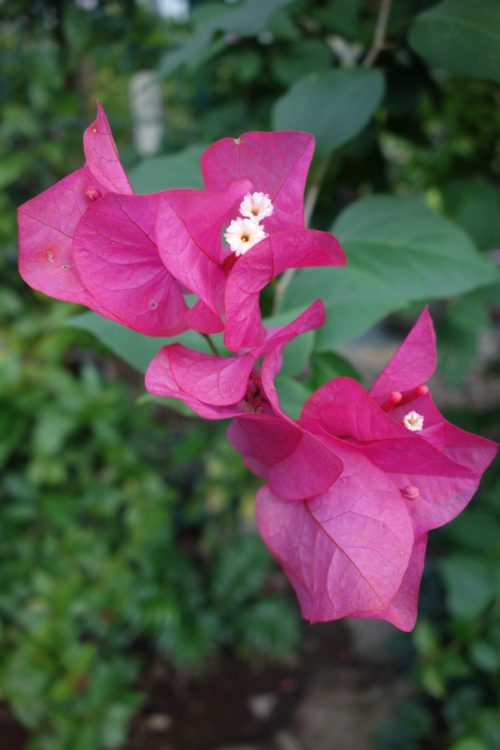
356 534 427 633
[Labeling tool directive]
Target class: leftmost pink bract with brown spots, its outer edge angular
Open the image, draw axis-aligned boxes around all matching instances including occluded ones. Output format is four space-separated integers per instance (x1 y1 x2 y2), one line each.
18 167 116 313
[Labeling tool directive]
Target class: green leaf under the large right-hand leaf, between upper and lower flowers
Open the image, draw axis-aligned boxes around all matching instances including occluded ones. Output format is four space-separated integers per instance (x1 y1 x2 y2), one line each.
281 266 406 351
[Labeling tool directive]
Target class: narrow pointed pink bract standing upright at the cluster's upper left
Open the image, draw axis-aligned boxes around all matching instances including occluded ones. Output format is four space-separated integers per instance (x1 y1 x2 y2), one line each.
83 102 134 195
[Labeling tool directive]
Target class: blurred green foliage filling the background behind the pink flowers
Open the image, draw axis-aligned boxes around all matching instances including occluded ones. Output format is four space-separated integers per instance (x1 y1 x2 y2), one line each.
0 0 500 750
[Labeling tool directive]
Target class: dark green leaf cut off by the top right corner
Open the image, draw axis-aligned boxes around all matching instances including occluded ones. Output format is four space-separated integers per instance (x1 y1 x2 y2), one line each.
409 0 500 83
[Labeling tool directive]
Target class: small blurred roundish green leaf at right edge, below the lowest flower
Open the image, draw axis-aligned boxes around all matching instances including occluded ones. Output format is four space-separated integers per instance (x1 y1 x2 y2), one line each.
439 555 495 619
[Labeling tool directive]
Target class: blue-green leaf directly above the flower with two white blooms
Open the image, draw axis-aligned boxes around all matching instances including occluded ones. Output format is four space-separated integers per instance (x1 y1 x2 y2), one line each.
272 68 384 156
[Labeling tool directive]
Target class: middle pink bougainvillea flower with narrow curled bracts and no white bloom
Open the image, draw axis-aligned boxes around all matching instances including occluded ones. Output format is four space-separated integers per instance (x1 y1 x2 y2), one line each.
146 302 342 499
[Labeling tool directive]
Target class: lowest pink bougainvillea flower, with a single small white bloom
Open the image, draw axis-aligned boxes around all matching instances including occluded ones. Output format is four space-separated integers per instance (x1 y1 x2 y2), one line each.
229 311 497 630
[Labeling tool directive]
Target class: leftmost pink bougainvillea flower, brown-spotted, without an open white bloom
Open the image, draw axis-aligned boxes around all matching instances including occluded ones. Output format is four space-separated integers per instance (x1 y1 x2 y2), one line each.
19 104 188 336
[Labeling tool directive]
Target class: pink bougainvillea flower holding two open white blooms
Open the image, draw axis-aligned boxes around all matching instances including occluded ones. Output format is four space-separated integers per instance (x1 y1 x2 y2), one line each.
150 132 345 351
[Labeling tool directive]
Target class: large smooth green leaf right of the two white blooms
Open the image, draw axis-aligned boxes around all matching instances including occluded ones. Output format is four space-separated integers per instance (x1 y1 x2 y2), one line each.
331 196 499 300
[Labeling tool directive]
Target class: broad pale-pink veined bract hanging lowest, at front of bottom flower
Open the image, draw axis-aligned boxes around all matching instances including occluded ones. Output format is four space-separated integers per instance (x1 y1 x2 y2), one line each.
257 448 413 622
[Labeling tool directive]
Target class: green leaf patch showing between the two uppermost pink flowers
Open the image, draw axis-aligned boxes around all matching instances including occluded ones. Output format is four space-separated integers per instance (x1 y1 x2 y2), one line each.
130 144 206 193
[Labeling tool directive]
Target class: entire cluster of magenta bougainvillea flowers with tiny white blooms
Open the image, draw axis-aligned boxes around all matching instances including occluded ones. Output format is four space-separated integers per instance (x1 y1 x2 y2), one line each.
19 106 497 630
